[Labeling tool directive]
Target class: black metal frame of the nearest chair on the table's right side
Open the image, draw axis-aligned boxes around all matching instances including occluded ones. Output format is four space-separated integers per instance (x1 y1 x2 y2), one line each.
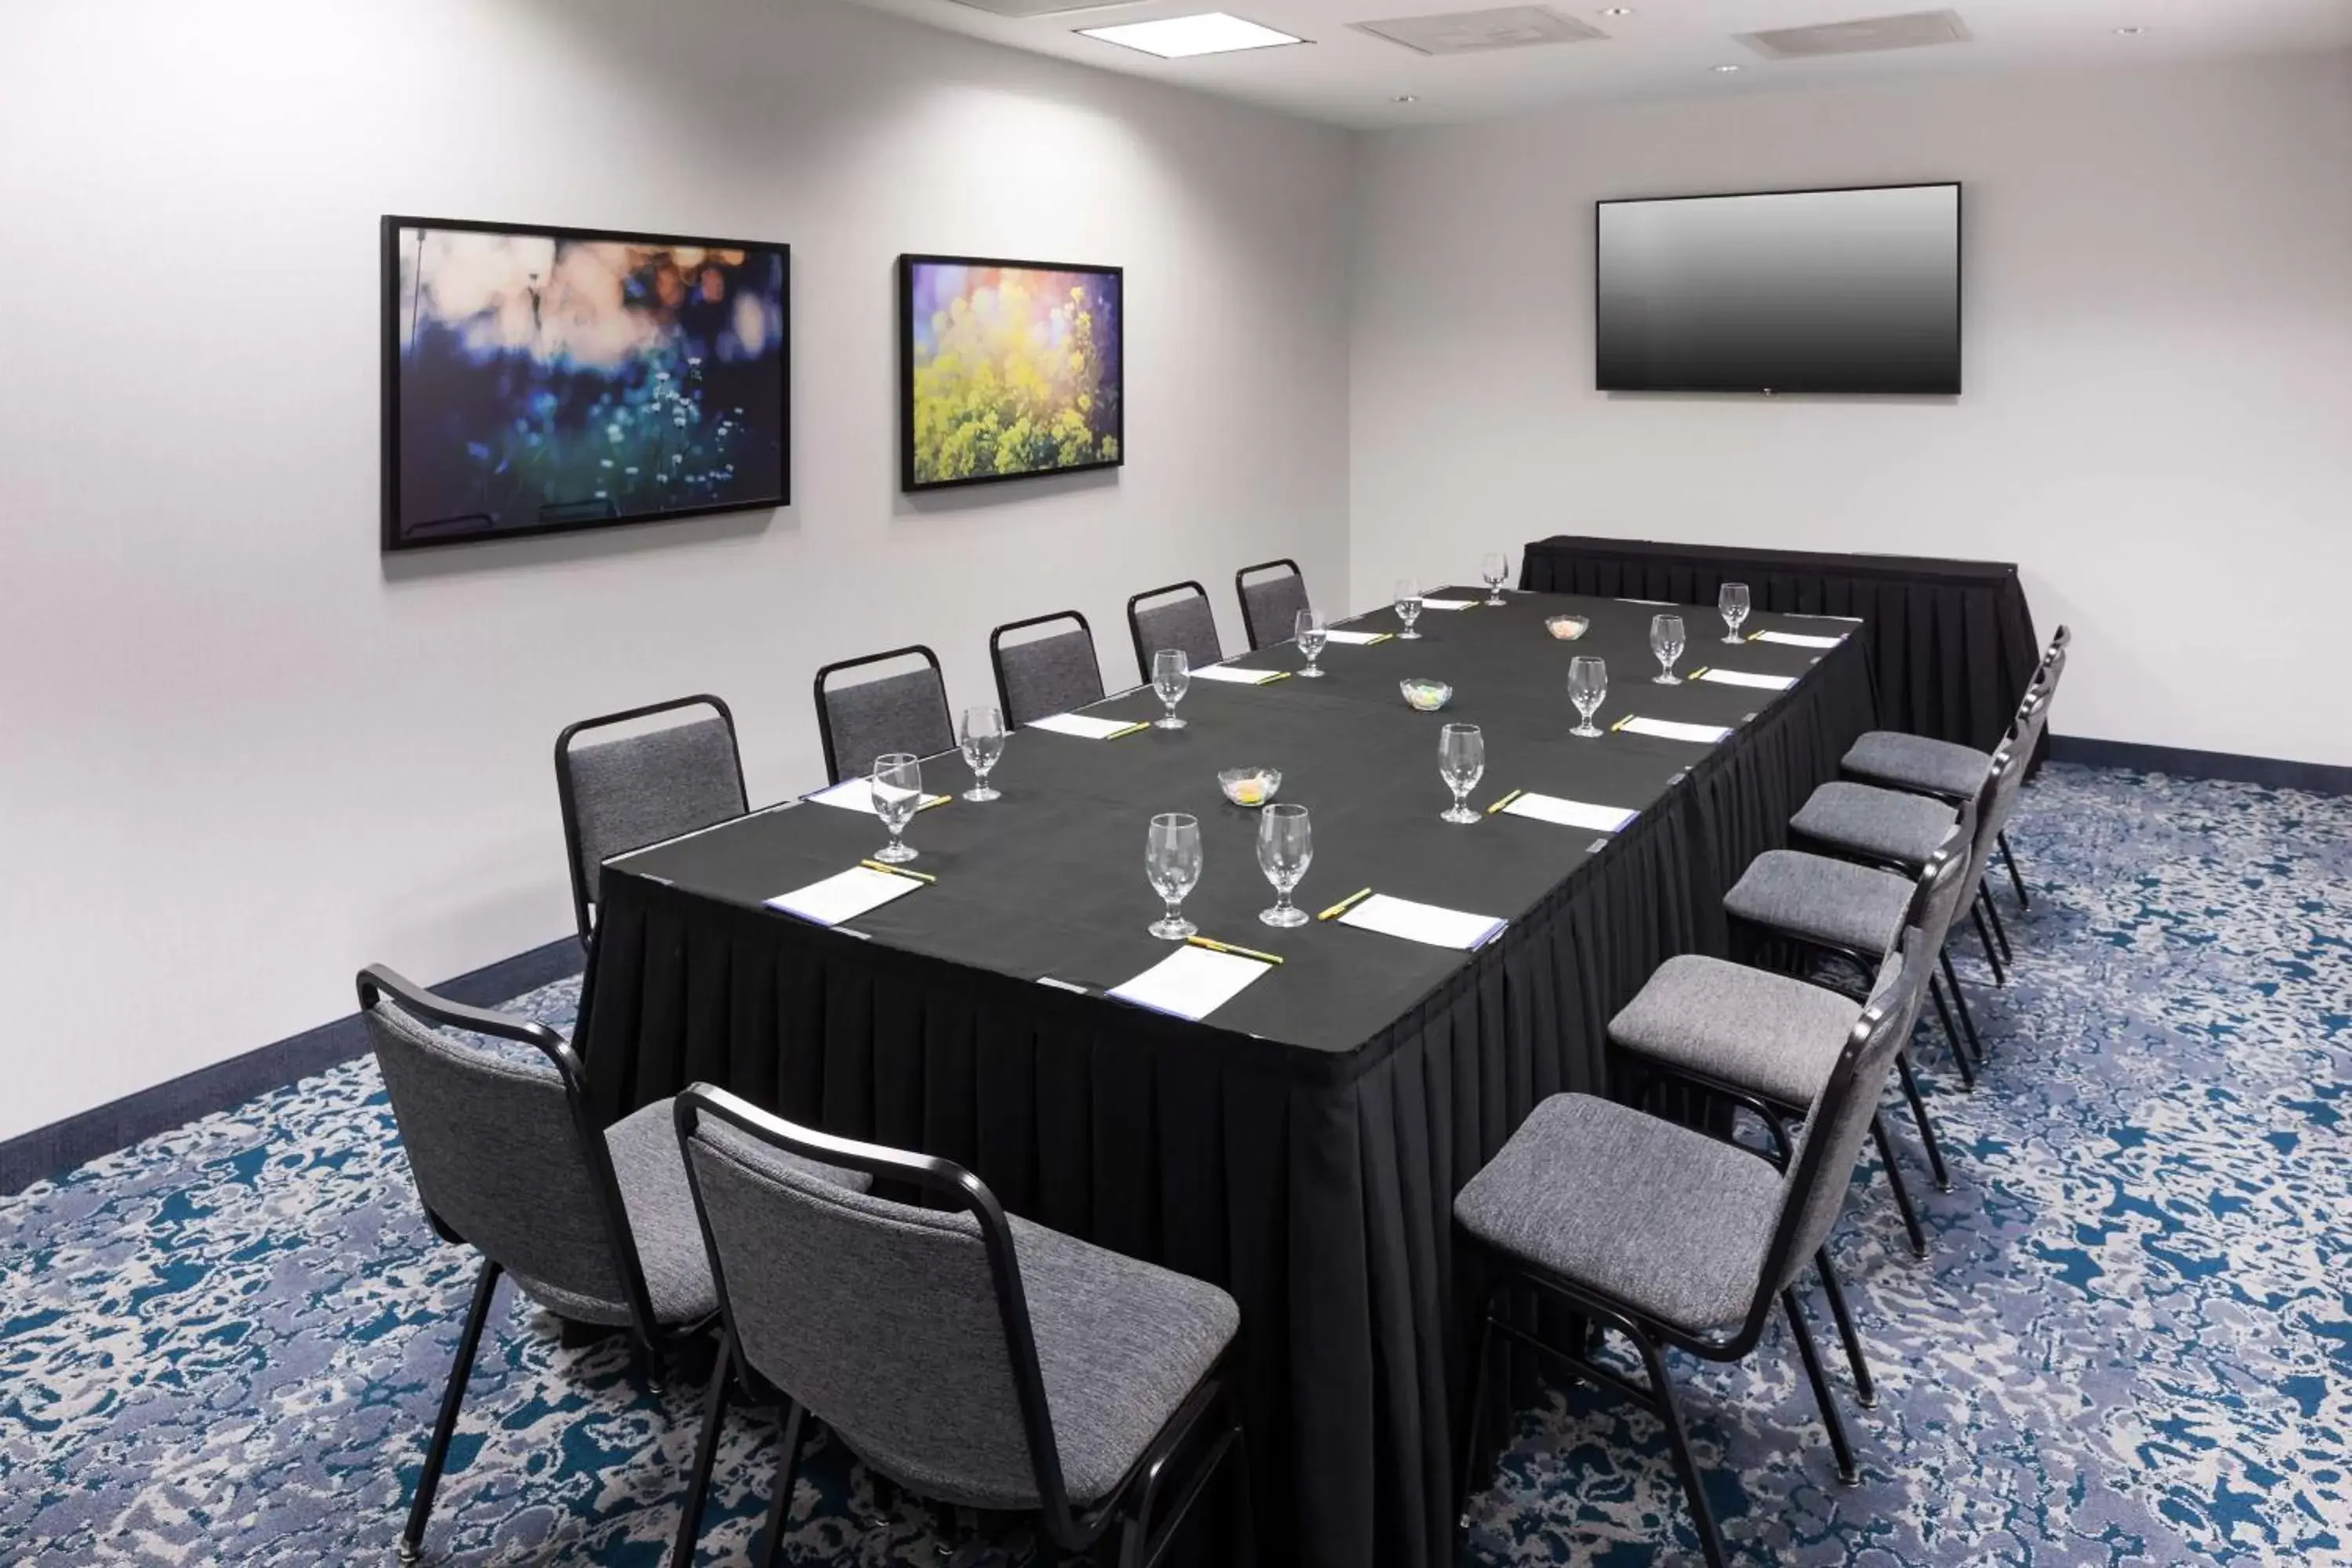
1458 945 1924 1568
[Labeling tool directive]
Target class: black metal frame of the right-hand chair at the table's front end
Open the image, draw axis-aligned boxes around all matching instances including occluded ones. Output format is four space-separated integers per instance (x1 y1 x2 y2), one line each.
673 1083 1256 1568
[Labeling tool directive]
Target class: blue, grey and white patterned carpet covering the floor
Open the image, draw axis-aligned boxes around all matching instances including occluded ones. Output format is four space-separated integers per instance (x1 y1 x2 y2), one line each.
0 767 2352 1568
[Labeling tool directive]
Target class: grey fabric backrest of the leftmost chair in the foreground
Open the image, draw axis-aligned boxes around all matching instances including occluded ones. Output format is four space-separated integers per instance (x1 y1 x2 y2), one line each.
358 966 654 1333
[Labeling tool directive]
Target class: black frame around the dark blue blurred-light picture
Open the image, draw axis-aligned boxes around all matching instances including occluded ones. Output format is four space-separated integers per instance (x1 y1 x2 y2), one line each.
379 214 793 555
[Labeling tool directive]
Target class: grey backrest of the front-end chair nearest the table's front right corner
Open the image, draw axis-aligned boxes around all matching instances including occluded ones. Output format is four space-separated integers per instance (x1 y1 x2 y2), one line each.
677 1083 1068 1516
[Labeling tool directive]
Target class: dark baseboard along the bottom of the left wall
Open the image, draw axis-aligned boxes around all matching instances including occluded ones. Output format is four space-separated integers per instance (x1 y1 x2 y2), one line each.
0 935 581 1196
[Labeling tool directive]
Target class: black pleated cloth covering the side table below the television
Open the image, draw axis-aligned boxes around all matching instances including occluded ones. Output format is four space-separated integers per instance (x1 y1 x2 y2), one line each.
1519 536 2049 753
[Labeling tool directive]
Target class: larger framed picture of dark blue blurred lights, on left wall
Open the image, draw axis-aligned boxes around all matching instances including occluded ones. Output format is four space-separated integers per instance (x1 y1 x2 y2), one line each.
383 216 793 550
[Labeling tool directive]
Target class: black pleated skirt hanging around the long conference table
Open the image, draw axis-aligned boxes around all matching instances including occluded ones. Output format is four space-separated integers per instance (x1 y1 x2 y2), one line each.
581 620 1875 1568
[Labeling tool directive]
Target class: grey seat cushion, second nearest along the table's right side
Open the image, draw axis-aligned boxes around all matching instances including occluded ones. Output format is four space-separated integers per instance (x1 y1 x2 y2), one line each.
1609 954 1863 1114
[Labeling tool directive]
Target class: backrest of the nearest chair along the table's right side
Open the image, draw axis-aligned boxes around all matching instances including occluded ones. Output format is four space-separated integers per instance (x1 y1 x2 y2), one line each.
1748 926 1936 1328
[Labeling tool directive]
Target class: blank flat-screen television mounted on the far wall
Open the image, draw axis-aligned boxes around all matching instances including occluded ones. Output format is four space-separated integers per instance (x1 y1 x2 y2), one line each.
1595 183 1959 395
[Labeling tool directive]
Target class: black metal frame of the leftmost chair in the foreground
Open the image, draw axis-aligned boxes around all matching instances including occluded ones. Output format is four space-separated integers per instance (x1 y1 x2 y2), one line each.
358 964 710 1563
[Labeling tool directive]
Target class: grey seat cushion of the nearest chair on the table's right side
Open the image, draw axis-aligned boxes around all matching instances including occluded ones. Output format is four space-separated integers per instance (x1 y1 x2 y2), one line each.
1454 1093 1780 1333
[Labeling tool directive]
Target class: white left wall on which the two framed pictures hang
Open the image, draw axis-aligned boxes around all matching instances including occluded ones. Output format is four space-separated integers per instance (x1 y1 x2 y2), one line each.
0 0 1350 1138
